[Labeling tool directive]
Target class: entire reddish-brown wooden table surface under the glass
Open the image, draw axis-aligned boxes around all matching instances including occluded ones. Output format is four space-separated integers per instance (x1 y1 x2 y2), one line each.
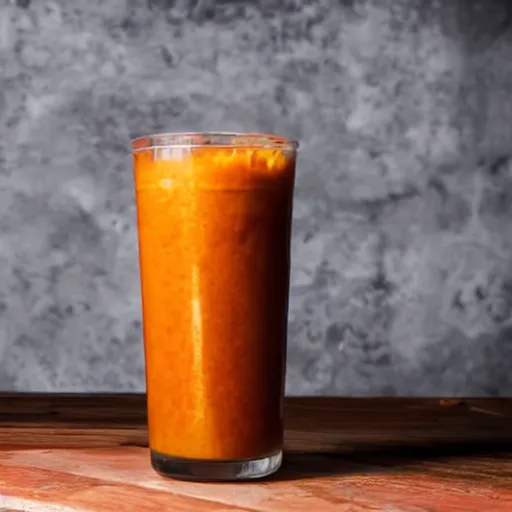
0 394 512 512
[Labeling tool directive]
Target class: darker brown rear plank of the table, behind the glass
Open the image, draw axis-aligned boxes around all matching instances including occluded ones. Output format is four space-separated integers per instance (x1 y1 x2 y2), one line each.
0 394 512 453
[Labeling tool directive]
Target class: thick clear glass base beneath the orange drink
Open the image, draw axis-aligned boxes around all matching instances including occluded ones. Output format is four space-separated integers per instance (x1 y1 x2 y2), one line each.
151 450 283 482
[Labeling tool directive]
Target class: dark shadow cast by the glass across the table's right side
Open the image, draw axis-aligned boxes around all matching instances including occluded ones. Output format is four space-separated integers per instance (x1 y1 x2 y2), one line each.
266 443 512 482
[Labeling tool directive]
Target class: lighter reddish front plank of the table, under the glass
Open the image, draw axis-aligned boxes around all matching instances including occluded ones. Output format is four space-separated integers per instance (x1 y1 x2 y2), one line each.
0 447 512 512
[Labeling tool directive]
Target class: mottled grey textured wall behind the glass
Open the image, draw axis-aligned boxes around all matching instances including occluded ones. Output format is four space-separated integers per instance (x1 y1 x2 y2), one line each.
0 0 512 395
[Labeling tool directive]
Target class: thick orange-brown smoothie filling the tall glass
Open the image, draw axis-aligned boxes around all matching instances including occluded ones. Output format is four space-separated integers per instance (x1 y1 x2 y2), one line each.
134 146 295 460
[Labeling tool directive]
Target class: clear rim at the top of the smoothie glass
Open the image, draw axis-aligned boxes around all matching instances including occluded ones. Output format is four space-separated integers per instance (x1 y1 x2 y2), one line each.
131 132 299 152
